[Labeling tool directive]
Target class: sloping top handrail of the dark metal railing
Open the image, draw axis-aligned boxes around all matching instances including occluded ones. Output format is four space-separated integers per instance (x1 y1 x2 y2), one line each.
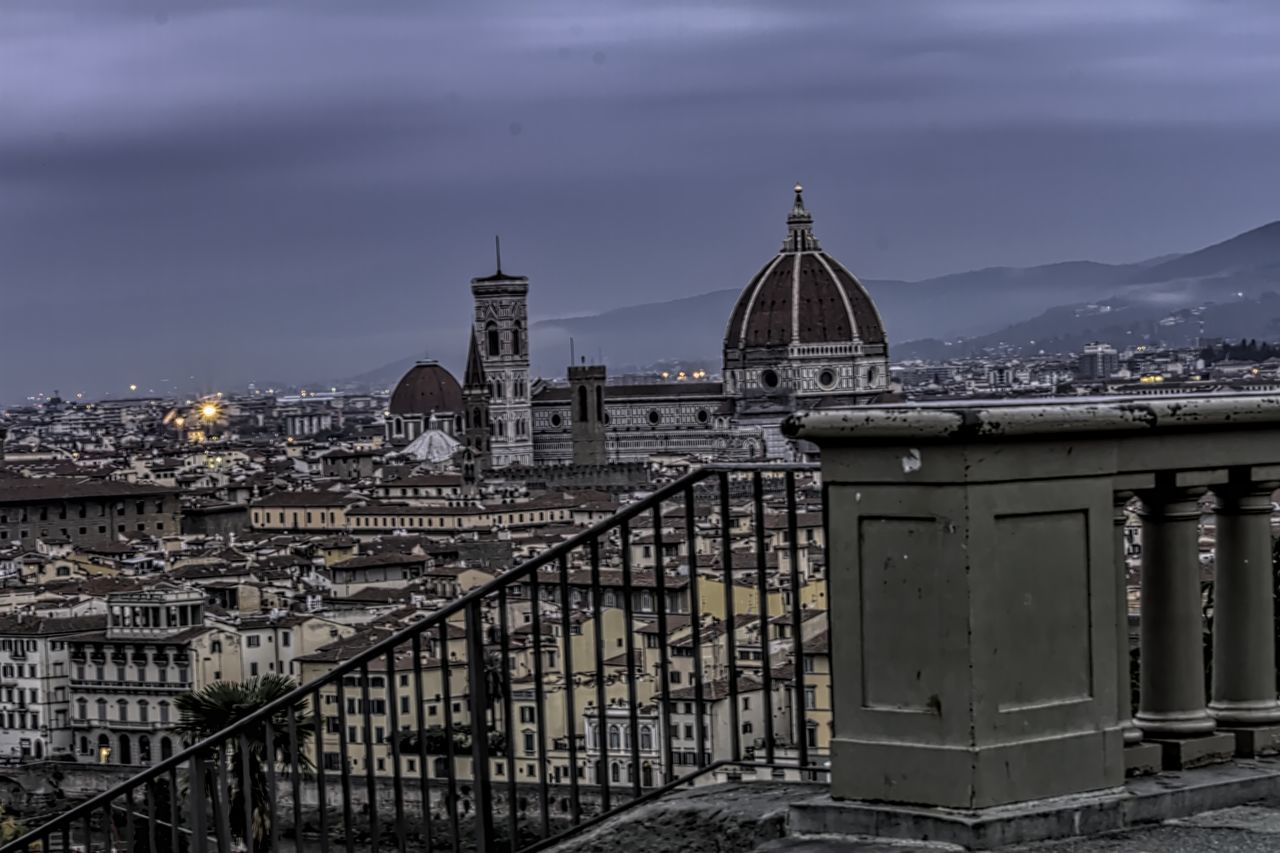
0 462 820 853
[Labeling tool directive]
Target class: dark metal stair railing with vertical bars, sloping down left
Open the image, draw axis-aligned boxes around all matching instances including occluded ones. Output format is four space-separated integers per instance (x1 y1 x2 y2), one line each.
0 465 829 853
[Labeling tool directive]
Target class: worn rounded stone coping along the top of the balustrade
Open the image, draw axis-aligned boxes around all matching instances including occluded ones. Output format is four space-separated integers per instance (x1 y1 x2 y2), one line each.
782 392 1280 444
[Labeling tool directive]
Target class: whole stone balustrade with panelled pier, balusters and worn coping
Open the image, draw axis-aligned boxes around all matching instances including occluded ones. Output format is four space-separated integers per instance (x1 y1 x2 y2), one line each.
786 394 1280 809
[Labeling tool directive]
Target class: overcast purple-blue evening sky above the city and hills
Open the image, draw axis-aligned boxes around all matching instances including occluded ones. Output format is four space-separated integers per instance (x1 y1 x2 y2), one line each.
0 0 1280 402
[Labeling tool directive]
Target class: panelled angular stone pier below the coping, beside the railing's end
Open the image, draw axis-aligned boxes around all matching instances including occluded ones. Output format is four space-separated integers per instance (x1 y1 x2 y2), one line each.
800 422 1128 809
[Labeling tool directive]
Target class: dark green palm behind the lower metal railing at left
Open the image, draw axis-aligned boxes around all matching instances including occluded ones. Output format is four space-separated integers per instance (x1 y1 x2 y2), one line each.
174 675 315 850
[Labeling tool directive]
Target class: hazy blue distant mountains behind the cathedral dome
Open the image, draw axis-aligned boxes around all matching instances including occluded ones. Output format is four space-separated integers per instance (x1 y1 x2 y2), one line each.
352 222 1280 386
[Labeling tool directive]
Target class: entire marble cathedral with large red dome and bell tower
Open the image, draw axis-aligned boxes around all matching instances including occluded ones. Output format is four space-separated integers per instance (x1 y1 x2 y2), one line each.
388 184 888 469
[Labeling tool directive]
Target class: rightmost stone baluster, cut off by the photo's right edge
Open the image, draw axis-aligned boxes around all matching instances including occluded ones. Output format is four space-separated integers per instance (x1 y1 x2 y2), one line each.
1208 469 1280 756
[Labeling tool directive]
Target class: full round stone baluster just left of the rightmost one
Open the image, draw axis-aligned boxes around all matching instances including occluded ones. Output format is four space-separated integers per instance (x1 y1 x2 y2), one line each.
1134 476 1235 770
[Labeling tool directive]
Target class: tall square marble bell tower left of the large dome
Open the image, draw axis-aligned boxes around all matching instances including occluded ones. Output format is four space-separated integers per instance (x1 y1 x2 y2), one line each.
471 251 534 467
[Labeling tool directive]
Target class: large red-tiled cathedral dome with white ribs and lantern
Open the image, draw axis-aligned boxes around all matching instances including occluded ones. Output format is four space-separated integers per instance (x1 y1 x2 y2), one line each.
724 184 884 356
